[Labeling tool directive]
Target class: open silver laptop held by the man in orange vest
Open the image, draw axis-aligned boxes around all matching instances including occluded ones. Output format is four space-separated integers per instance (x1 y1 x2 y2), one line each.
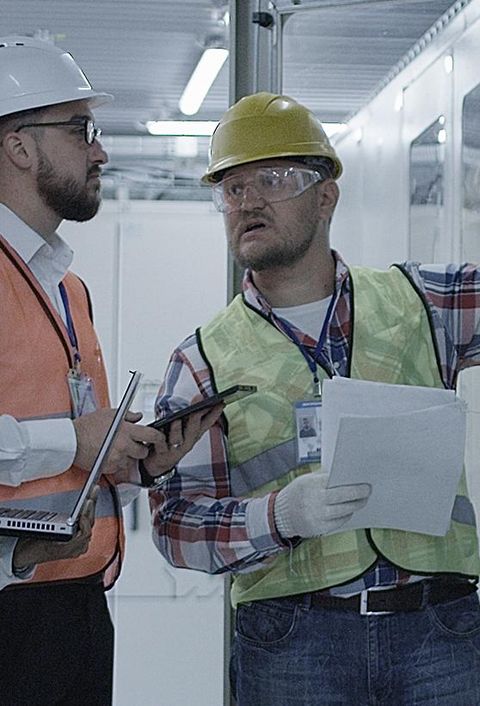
0 371 142 541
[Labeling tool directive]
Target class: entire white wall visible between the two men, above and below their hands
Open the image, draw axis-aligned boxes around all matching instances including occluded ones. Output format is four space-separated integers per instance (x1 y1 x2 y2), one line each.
61 201 227 706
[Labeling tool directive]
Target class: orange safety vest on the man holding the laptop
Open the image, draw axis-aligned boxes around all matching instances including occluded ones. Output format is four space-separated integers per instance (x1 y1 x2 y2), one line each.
0 236 124 588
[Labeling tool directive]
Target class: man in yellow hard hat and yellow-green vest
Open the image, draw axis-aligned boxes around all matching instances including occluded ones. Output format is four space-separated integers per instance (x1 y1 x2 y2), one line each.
151 93 480 706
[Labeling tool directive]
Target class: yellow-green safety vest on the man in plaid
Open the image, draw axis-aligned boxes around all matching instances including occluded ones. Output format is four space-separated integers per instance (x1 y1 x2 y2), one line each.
199 268 480 604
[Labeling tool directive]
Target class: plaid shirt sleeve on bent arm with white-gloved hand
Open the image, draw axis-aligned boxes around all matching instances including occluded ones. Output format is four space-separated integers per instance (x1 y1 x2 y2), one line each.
150 336 286 574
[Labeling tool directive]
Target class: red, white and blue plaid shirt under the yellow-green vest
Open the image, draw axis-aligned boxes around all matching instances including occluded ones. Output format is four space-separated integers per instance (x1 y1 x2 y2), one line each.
150 252 480 595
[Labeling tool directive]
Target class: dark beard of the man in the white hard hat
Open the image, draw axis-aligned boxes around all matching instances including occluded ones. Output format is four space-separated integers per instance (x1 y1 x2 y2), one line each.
37 147 100 221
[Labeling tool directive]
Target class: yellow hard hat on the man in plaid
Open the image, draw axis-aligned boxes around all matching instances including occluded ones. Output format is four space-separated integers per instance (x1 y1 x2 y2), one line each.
202 92 342 184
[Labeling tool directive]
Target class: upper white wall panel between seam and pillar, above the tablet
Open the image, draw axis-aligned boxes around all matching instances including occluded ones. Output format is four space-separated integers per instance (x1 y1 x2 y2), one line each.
119 201 227 396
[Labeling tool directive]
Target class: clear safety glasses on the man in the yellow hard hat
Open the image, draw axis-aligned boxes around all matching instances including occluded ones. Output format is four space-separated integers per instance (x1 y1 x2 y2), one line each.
213 167 324 213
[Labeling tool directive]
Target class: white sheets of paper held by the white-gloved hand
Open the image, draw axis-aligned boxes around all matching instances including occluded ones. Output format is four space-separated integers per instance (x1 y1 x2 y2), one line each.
322 378 466 536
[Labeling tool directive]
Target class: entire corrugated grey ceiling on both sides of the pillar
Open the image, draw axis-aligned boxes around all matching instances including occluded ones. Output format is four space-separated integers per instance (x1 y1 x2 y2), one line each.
0 0 467 199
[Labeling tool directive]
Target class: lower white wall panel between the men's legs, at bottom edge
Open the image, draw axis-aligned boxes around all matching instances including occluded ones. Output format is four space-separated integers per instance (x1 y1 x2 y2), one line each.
115 595 223 706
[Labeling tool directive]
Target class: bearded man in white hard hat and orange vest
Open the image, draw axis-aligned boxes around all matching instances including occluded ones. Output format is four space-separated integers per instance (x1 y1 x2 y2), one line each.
0 37 221 706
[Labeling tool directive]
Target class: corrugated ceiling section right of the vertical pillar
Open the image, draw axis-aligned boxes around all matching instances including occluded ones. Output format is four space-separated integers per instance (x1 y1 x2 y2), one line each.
281 0 461 122
